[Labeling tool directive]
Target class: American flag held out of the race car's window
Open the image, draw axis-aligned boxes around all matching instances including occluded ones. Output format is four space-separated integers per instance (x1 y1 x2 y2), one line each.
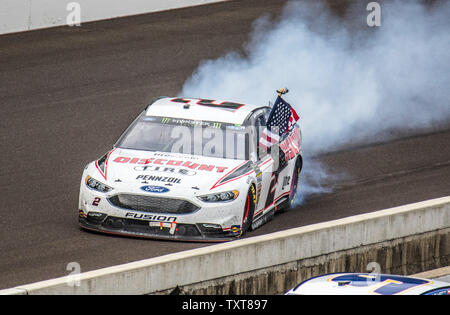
259 96 299 151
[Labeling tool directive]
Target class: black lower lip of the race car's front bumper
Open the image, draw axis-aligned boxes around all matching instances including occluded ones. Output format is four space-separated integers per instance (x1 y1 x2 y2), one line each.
78 211 240 242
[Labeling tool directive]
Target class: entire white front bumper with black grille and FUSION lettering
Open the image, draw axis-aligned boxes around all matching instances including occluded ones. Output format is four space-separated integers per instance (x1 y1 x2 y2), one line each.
78 171 246 242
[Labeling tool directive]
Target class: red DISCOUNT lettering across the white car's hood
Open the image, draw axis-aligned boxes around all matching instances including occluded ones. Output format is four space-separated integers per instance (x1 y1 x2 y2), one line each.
114 156 228 173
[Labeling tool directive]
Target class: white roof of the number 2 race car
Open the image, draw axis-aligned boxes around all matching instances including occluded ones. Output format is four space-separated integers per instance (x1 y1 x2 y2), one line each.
146 97 266 124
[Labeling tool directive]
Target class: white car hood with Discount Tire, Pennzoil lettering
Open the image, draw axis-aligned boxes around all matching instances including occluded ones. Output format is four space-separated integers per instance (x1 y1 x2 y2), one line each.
95 148 251 195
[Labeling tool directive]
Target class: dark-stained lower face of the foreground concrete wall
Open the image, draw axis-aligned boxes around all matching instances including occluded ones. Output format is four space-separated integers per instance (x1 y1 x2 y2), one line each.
155 229 450 295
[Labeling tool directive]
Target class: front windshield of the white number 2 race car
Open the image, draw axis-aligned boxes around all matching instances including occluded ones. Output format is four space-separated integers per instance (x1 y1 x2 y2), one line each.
117 116 249 160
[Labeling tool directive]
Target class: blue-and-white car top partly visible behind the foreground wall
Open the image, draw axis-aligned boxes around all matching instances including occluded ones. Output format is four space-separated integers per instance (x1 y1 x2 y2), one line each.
288 273 450 295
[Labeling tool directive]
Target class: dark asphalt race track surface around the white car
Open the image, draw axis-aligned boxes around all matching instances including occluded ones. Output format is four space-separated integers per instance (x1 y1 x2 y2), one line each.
0 0 450 289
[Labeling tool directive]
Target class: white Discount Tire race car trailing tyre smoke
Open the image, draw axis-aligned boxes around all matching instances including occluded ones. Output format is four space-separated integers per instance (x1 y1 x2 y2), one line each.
78 97 302 241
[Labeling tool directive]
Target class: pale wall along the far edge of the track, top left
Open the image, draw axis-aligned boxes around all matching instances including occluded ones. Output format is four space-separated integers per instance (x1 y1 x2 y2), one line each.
0 0 226 34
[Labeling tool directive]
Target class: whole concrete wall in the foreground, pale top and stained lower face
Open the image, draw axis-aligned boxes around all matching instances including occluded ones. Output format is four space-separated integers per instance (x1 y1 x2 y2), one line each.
0 197 450 294
